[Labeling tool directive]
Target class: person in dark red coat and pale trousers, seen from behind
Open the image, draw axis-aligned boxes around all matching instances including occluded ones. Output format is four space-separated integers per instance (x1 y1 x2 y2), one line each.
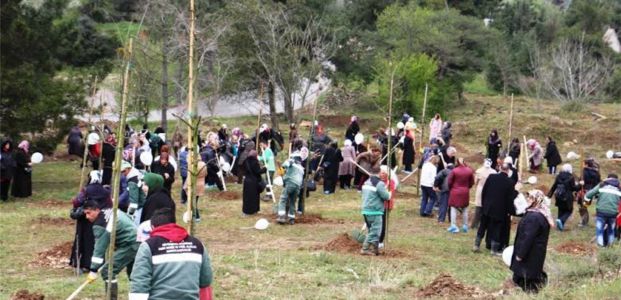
447 157 474 233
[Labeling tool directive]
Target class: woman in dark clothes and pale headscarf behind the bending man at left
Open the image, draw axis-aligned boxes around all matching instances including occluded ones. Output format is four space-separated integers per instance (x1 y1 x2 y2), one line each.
69 171 112 271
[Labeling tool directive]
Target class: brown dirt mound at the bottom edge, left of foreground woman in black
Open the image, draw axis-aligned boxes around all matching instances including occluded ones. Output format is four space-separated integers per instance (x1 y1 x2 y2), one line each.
416 274 488 299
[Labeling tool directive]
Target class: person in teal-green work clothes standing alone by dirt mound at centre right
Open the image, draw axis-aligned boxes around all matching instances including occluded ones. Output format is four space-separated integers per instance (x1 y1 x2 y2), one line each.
360 169 390 255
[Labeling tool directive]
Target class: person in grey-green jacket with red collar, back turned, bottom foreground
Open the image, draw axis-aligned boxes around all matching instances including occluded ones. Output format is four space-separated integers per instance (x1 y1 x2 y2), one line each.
128 208 213 300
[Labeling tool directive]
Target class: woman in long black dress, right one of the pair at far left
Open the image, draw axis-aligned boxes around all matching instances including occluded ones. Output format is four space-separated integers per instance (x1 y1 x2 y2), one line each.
11 140 32 198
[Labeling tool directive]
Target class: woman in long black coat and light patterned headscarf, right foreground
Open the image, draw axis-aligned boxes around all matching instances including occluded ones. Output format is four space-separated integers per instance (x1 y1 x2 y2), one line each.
511 190 554 293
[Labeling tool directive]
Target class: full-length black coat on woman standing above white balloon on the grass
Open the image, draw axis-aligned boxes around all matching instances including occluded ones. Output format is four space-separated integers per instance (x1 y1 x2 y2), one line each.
242 156 267 215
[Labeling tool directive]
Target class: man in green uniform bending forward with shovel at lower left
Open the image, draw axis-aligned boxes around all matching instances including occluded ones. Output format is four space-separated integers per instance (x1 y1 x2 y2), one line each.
83 201 139 299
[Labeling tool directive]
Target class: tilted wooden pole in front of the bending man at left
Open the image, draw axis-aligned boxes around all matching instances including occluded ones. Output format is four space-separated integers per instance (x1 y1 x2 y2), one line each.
106 38 133 300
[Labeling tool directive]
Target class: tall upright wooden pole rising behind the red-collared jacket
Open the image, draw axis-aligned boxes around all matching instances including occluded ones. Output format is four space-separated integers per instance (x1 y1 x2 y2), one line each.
186 0 199 235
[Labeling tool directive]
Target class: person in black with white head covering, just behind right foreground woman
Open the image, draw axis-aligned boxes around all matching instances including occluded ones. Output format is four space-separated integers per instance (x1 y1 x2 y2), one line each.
548 164 580 231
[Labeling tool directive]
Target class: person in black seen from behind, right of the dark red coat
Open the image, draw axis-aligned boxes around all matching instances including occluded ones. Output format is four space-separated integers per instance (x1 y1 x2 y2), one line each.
473 164 517 255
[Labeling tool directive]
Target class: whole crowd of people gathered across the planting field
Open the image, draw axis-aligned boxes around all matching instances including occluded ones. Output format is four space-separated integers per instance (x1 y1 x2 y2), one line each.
0 113 621 299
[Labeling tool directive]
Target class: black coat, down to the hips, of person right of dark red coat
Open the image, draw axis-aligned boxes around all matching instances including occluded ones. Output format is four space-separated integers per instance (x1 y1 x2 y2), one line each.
481 172 517 220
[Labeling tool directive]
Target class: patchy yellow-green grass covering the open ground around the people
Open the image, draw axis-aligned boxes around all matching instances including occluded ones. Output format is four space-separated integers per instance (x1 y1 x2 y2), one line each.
0 95 621 299
